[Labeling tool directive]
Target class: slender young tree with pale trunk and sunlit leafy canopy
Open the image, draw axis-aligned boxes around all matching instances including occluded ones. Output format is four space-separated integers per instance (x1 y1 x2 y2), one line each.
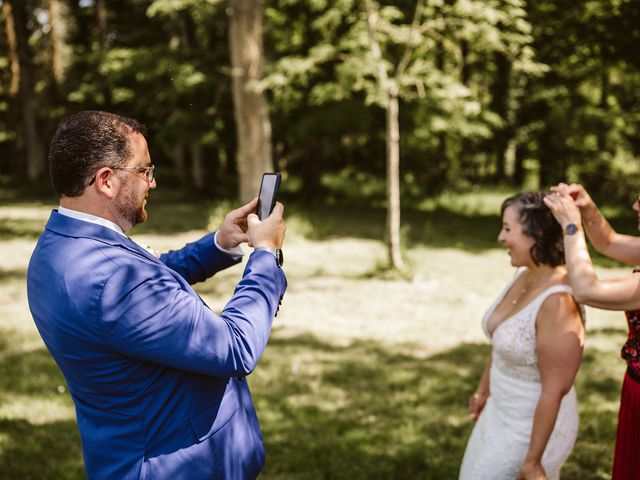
268 0 532 268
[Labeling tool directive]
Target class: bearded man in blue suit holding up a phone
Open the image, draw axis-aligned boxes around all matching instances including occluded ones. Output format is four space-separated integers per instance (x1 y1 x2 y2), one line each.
27 111 286 480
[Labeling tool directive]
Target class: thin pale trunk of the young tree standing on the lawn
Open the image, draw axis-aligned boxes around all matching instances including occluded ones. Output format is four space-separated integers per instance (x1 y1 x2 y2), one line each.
387 85 404 270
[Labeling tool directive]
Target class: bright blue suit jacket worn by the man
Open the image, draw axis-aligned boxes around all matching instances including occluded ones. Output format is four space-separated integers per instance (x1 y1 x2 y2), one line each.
27 211 286 480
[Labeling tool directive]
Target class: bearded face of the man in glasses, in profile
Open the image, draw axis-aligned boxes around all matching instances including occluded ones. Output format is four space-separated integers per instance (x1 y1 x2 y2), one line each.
114 133 156 227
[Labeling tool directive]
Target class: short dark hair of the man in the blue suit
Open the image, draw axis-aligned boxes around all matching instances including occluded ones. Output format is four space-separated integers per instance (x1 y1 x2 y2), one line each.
49 110 146 198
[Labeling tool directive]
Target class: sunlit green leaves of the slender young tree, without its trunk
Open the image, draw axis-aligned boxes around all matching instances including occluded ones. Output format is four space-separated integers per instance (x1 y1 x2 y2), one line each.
263 1 545 199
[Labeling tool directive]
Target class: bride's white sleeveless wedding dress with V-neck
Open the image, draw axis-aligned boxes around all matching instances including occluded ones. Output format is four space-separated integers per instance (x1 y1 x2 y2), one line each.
460 268 578 480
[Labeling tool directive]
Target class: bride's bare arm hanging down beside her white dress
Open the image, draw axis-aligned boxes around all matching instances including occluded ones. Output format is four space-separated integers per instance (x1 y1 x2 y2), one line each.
517 293 584 480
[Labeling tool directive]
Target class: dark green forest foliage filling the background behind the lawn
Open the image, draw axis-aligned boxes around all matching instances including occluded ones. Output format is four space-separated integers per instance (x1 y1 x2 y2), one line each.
0 0 640 203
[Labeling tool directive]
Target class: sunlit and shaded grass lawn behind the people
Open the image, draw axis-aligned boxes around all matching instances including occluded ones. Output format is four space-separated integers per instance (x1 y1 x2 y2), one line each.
0 189 633 480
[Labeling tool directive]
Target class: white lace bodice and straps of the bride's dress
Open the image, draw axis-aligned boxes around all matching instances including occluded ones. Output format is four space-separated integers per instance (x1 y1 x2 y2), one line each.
482 268 573 382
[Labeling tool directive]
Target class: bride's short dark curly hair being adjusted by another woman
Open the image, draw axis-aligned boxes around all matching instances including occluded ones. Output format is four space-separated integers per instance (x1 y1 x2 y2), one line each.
501 192 565 267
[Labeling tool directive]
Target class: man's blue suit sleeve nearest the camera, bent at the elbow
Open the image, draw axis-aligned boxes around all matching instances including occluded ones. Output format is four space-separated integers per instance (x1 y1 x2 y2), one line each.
99 251 286 377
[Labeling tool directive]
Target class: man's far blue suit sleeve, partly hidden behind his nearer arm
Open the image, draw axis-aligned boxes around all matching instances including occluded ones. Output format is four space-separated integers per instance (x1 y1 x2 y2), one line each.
160 232 241 285
